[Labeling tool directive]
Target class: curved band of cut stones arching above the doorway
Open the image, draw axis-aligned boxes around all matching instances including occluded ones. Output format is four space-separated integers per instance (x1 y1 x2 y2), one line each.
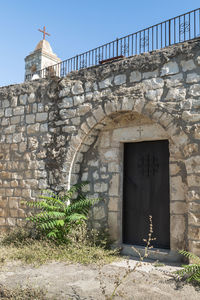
66 97 187 187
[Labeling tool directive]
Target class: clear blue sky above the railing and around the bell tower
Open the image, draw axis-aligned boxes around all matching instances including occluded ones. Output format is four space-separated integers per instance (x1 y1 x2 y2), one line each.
0 0 200 86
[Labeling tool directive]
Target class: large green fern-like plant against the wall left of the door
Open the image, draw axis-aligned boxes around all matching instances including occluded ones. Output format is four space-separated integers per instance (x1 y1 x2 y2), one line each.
25 182 98 242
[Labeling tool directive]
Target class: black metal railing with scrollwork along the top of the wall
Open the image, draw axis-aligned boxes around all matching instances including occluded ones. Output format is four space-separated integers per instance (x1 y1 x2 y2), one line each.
26 8 200 80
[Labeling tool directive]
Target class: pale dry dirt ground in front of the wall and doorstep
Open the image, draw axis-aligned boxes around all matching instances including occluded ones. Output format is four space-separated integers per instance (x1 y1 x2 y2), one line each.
0 260 200 300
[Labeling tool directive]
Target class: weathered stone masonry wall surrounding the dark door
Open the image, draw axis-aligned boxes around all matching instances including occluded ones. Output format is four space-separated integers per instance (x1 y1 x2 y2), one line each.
0 40 200 254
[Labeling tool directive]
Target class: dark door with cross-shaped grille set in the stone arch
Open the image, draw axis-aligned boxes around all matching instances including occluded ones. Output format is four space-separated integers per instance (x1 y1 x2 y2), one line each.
123 140 170 249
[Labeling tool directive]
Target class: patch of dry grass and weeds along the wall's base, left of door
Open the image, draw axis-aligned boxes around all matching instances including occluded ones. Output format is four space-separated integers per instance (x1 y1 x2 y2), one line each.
0 224 119 265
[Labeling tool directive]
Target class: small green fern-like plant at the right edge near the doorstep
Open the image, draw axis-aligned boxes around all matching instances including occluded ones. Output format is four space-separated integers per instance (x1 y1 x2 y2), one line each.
176 250 200 284
